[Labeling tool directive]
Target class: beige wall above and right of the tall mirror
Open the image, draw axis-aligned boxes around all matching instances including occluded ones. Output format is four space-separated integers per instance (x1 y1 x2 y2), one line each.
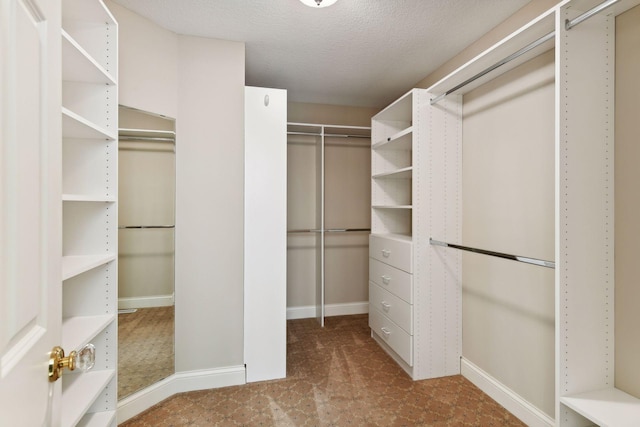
108 2 245 372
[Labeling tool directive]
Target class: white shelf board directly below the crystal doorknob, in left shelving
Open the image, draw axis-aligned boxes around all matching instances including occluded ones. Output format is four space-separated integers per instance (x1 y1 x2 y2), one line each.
61 369 116 427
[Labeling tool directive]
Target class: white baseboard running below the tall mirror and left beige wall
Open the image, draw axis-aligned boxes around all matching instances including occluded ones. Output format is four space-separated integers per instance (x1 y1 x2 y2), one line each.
117 366 246 424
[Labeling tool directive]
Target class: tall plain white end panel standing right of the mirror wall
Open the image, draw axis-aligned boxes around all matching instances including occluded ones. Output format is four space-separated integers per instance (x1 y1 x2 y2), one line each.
244 87 287 382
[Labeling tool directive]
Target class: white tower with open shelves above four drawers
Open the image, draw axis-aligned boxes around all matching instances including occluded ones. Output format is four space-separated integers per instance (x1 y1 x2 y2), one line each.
369 89 462 380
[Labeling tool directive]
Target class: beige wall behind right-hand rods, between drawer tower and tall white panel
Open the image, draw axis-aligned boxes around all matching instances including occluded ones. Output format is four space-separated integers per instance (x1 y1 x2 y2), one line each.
462 51 555 417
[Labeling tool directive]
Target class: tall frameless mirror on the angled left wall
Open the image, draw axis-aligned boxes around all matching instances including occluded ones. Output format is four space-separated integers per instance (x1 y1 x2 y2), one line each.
118 106 176 399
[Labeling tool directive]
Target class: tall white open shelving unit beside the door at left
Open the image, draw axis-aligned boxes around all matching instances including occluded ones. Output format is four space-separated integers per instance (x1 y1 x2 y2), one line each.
61 0 118 426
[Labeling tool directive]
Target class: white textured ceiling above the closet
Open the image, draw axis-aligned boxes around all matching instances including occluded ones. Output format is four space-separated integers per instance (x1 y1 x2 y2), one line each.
114 0 529 107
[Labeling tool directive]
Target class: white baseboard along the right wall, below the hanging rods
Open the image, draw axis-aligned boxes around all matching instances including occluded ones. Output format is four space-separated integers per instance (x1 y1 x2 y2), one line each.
460 357 555 427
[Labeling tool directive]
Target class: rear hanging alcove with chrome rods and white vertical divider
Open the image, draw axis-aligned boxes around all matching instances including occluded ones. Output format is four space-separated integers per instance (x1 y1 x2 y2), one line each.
287 122 371 324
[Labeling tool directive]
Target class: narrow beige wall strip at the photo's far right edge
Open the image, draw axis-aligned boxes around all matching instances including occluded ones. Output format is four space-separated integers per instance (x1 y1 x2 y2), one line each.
615 6 640 397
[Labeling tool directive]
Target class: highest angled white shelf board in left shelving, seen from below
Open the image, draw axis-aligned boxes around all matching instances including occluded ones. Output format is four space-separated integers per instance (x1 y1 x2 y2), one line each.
62 30 116 85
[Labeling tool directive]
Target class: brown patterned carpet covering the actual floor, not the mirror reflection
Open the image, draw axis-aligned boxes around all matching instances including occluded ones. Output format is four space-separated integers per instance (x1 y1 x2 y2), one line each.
122 315 524 427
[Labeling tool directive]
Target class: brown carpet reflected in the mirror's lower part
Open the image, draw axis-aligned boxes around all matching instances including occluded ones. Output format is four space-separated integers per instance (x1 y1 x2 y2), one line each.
118 307 174 399
